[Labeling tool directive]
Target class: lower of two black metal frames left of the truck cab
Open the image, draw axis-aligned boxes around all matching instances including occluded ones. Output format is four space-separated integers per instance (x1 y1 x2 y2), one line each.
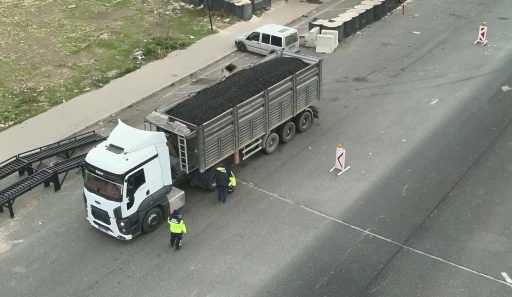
0 154 87 218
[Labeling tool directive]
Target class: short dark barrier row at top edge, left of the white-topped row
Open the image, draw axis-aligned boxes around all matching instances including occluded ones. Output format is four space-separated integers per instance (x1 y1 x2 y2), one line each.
187 0 271 21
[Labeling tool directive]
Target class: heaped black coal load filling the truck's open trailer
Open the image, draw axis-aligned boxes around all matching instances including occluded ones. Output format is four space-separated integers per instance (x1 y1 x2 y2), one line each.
167 58 308 126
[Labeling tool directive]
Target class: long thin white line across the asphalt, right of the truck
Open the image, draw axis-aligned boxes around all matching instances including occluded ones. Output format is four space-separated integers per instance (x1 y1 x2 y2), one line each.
237 179 512 288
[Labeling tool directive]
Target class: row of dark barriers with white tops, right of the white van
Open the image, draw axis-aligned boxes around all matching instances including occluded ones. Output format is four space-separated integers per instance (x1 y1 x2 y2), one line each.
309 0 404 42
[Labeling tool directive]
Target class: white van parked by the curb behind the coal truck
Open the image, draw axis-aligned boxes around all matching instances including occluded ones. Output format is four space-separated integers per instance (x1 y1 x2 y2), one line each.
235 24 300 55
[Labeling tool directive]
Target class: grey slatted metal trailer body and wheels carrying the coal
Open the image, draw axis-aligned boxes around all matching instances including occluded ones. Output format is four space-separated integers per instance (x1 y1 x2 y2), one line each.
144 52 322 190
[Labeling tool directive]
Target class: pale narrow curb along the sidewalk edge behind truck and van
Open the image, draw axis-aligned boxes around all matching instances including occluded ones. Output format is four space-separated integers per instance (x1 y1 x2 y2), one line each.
76 0 343 137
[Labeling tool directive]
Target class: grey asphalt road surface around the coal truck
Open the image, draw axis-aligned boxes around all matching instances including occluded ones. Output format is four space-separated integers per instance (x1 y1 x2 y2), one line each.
0 0 512 297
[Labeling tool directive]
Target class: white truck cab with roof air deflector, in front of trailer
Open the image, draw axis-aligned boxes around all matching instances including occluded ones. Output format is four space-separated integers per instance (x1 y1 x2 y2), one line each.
83 120 185 240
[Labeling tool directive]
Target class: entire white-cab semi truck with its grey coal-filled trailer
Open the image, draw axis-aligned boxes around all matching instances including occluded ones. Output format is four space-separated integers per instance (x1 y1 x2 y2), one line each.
83 52 322 240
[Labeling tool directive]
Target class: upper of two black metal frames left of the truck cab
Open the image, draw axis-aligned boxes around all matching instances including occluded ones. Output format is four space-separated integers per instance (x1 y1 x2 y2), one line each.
0 131 106 180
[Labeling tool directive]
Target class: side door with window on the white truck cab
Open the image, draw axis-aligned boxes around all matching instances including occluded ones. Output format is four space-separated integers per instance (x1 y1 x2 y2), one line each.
121 168 151 217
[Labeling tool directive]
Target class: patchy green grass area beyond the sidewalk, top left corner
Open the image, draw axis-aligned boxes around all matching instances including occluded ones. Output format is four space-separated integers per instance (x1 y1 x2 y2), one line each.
0 0 243 131
